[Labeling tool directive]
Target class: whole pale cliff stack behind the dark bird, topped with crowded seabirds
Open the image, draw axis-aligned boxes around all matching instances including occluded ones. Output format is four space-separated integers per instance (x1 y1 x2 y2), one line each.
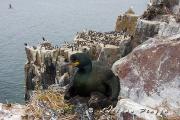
25 31 130 100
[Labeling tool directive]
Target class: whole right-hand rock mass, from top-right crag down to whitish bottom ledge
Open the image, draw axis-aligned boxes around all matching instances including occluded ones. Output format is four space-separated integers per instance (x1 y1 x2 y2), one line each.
112 0 180 120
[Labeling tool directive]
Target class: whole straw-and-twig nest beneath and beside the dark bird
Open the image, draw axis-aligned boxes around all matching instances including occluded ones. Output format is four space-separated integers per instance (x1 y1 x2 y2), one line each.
23 86 116 120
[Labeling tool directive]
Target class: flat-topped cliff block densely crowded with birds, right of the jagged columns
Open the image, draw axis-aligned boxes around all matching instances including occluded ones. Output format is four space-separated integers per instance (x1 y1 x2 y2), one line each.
75 31 131 67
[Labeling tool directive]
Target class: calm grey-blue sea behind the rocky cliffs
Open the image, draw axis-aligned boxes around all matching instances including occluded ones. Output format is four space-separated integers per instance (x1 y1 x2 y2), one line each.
0 0 147 103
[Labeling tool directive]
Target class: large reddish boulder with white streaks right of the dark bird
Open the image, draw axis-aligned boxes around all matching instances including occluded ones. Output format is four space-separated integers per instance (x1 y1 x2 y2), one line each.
112 35 180 115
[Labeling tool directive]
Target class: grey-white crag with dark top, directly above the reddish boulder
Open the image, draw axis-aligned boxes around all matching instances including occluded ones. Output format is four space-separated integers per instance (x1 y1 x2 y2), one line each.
132 0 179 48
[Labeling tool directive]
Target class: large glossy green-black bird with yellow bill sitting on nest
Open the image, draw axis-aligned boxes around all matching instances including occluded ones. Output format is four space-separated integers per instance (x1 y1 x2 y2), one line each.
65 53 120 107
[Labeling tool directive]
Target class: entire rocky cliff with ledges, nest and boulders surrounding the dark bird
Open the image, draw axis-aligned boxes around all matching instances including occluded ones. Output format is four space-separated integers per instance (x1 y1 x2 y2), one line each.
0 0 180 120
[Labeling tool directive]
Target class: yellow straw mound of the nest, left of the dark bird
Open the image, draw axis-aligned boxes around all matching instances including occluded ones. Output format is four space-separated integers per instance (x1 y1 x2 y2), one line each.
26 90 76 120
